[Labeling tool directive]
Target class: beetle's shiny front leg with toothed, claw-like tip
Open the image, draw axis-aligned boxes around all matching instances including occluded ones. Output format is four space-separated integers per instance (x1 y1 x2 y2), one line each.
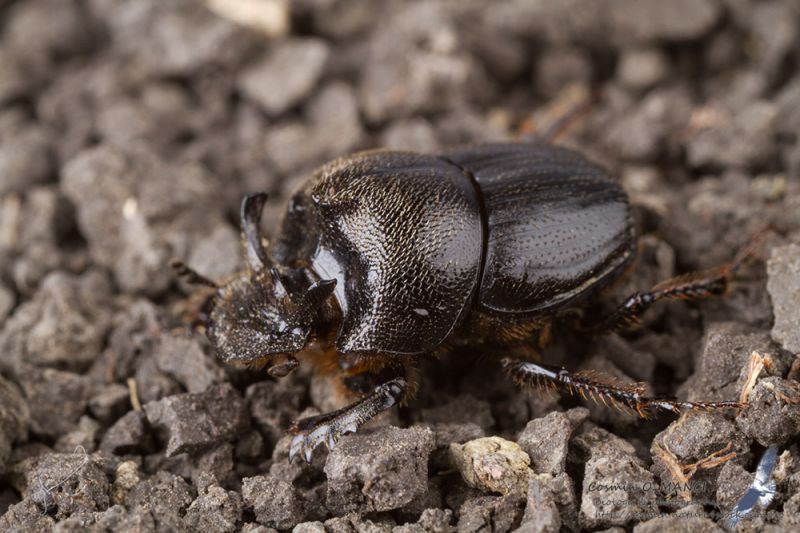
289 378 406 463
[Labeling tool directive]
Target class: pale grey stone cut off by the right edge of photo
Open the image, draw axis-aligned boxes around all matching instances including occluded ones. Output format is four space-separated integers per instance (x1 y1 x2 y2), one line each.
767 244 800 354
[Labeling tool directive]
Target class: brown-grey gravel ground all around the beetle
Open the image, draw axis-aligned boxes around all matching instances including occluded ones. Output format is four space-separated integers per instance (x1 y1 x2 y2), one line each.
0 0 800 532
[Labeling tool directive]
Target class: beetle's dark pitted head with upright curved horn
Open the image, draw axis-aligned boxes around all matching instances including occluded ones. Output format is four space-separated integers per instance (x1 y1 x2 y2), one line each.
206 194 336 364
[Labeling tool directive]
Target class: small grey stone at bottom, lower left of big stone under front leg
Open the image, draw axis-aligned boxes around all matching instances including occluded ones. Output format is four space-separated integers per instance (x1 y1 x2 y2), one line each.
242 476 306 529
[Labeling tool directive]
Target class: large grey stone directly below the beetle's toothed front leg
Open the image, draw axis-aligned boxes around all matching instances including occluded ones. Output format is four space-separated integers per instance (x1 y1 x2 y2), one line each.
325 427 434 514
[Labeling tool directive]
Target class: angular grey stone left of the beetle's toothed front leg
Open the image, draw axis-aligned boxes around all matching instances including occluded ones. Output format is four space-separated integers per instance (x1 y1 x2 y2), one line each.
144 383 248 457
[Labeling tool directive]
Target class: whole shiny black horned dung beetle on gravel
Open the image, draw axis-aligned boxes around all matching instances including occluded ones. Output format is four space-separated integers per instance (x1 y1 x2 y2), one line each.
173 142 746 461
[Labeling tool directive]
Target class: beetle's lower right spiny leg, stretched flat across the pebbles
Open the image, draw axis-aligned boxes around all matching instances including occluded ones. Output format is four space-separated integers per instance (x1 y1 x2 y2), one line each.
502 358 742 418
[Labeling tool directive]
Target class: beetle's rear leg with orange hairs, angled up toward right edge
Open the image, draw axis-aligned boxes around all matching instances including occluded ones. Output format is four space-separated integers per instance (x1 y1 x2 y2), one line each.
580 228 769 333
